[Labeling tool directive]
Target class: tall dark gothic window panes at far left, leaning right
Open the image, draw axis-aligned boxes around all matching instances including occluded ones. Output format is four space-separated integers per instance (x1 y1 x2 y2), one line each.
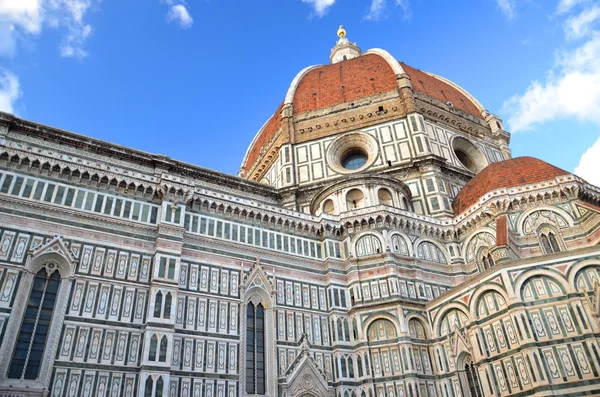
8 268 60 380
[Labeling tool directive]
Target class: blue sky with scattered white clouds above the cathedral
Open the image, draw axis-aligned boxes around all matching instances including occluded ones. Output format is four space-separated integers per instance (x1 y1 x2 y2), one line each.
0 0 600 184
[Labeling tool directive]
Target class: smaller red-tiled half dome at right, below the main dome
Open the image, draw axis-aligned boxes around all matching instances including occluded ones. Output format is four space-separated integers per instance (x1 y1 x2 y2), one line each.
452 157 571 215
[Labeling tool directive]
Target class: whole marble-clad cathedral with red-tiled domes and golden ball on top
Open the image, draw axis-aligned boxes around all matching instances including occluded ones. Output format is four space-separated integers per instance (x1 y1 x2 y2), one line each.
0 27 600 397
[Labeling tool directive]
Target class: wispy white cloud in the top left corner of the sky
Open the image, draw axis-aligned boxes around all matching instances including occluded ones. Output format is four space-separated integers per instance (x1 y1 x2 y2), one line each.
0 0 99 58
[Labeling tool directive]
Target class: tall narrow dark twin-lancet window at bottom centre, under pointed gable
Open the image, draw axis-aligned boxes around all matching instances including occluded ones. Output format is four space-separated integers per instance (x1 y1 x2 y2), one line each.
246 303 265 394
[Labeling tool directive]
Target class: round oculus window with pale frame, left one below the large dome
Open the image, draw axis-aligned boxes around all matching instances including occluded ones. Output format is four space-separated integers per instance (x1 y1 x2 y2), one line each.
327 132 377 174
